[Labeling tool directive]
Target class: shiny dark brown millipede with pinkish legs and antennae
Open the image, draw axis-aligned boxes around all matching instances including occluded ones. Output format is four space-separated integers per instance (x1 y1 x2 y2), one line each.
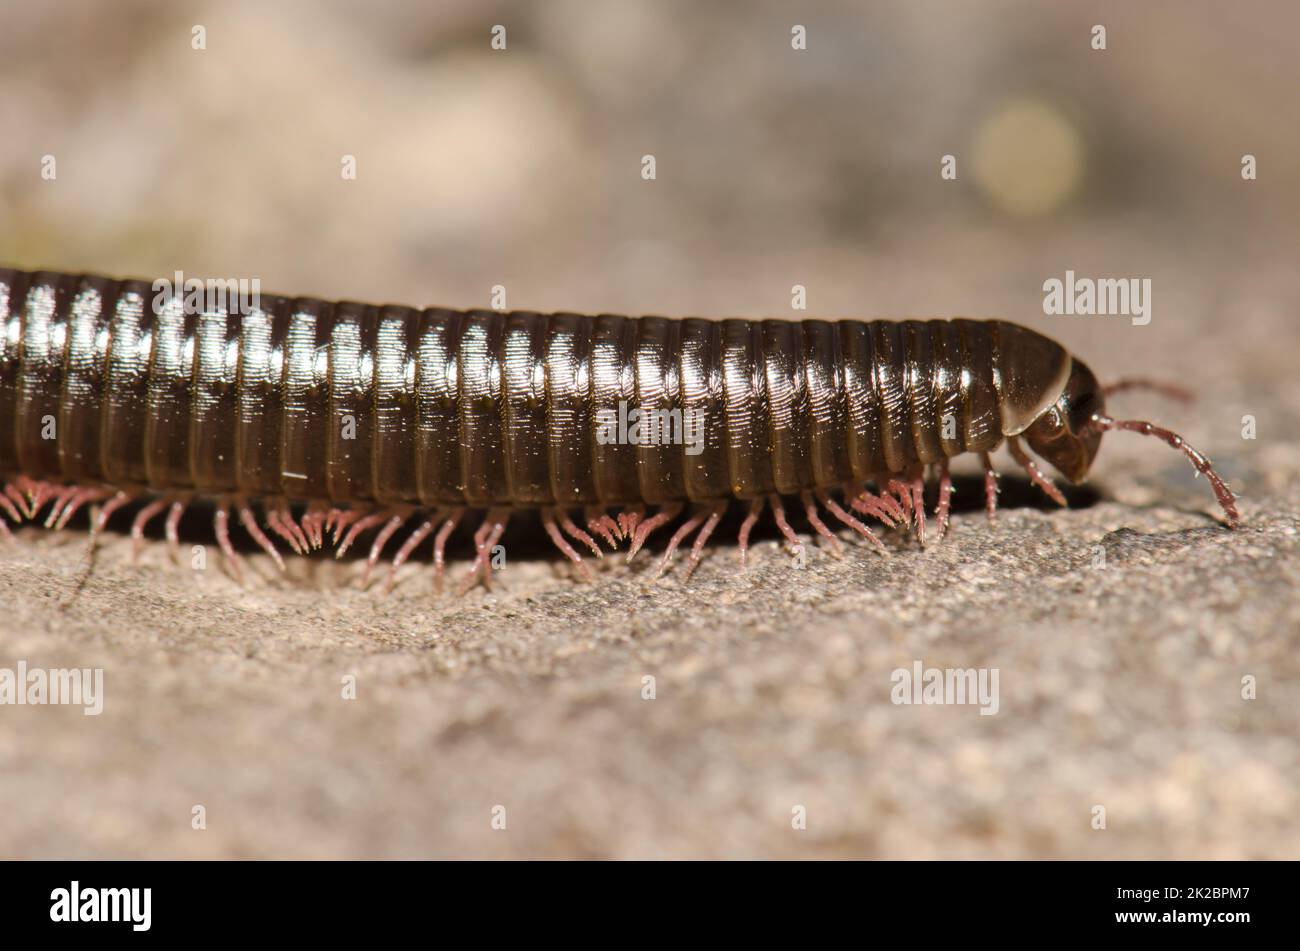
0 269 1240 591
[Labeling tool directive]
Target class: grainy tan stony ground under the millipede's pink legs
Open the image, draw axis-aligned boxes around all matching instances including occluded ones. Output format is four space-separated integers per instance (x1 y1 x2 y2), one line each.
0 413 1300 857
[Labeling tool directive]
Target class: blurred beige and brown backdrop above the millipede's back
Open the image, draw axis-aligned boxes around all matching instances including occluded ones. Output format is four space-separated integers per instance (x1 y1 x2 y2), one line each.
0 0 1300 385
